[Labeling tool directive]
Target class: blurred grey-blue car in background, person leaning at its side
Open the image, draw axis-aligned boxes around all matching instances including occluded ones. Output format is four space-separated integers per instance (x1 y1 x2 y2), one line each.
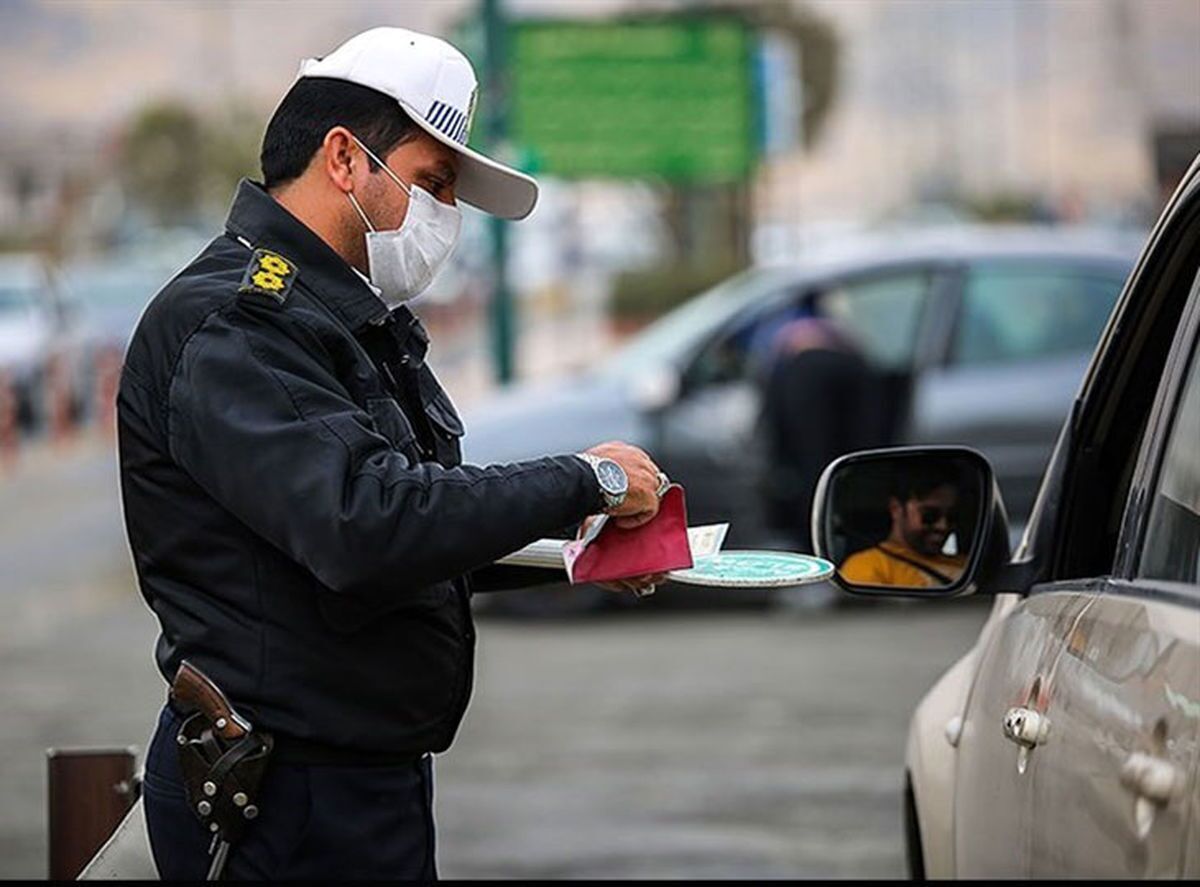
464 228 1140 611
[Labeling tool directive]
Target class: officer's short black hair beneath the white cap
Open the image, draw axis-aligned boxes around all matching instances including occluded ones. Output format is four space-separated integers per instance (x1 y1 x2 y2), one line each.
260 77 420 191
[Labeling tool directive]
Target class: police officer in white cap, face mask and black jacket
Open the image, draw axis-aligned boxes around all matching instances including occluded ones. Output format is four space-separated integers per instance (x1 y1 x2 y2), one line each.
118 28 662 879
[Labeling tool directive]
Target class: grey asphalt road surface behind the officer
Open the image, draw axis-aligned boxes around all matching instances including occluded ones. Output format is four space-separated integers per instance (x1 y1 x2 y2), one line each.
0 434 985 877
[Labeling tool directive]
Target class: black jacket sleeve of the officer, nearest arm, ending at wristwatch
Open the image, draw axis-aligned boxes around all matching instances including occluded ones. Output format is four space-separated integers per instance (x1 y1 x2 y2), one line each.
167 306 600 598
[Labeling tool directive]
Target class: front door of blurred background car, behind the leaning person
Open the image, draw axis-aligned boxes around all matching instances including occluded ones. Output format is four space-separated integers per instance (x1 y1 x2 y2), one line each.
653 265 932 544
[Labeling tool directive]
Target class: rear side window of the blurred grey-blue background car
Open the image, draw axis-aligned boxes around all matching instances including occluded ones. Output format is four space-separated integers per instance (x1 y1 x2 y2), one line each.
953 265 1124 366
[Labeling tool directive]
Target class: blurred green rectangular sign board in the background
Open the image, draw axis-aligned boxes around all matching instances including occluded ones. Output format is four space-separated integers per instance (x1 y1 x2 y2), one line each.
509 16 758 184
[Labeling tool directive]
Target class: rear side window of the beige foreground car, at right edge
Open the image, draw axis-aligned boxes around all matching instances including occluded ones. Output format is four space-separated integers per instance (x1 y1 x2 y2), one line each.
1138 336 1200 585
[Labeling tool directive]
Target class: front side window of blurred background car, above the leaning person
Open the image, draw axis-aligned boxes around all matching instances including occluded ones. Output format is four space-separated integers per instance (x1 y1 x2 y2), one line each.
818 271 930 370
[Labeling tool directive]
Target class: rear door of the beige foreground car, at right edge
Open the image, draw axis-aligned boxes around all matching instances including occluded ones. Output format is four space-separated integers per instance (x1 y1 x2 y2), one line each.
1030 277 1200 879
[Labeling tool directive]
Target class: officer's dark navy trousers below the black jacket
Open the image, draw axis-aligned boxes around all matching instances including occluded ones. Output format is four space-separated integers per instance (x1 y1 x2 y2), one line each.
143 707 437 881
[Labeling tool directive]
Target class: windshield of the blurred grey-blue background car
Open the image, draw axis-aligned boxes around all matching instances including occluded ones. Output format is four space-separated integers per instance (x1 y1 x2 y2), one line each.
600 269 797 377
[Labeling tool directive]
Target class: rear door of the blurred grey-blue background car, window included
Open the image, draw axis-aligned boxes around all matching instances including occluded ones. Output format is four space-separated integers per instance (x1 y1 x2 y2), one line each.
908 259 1126 525
